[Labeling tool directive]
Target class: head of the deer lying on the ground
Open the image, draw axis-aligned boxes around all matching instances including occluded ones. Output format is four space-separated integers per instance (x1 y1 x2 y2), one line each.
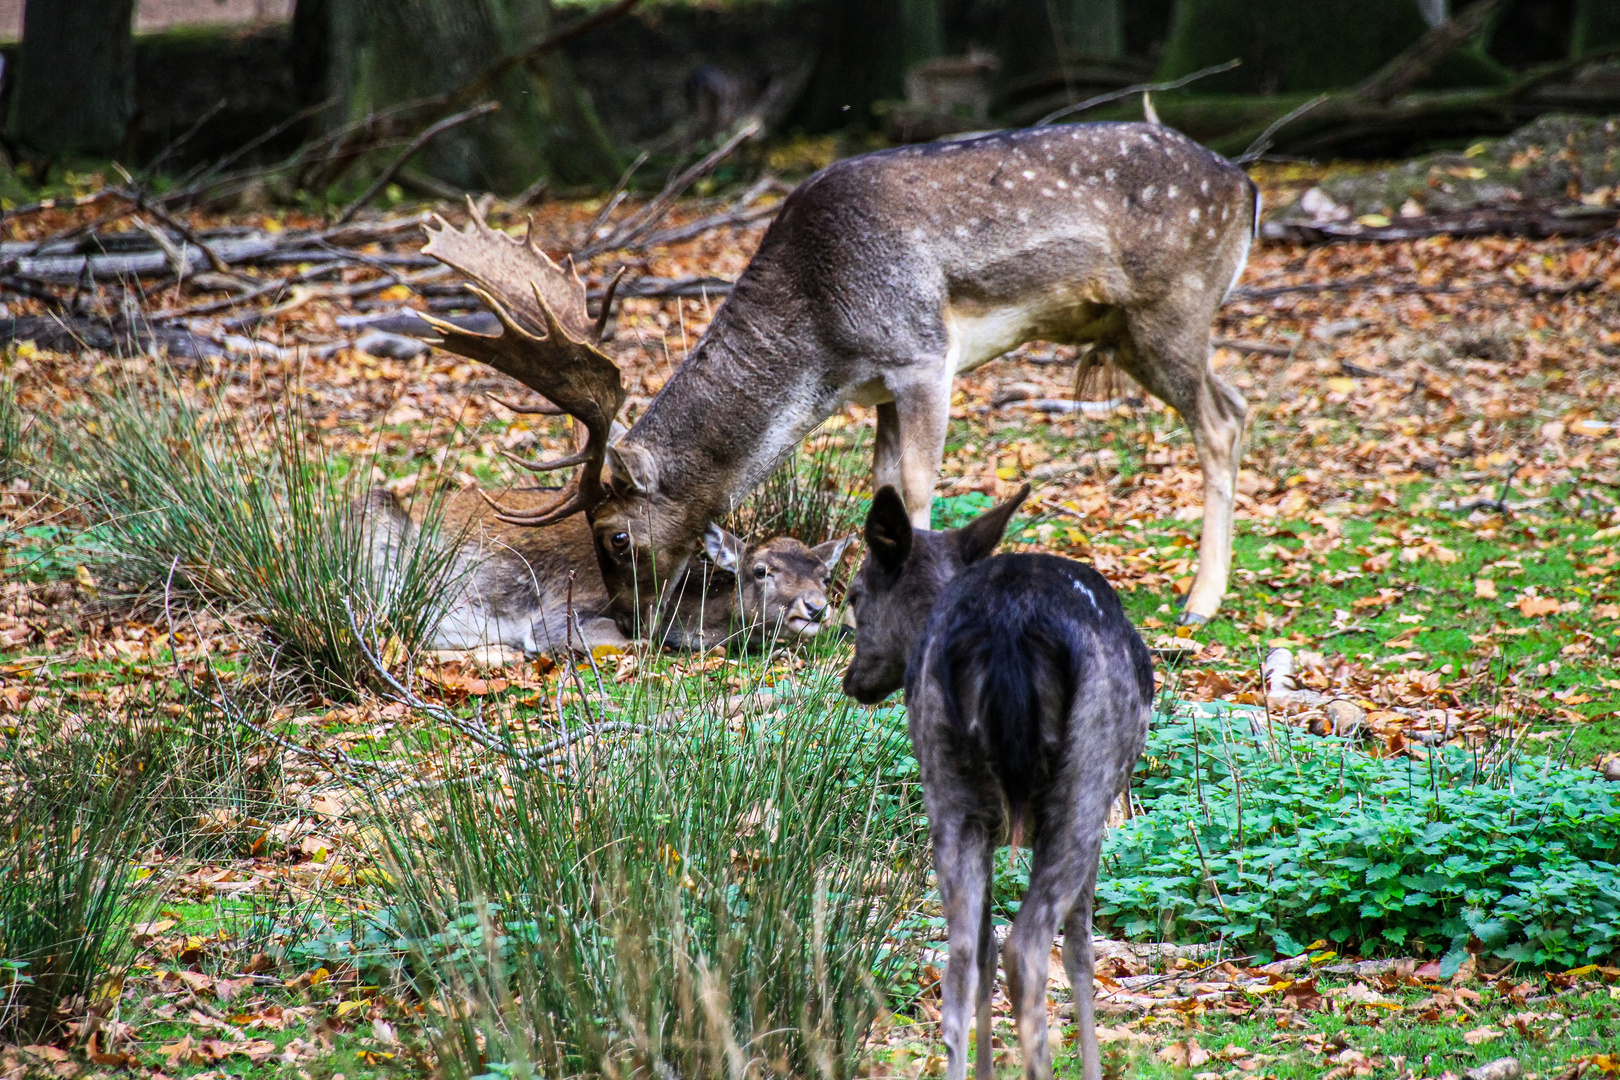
703 525 854 638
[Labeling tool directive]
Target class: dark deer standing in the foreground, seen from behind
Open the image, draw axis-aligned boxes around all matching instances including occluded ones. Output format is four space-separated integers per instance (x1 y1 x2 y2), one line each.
844 486 1153 1080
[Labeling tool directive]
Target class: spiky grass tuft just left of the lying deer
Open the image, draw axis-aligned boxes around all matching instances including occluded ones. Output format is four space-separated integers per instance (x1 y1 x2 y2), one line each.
50 375 455 691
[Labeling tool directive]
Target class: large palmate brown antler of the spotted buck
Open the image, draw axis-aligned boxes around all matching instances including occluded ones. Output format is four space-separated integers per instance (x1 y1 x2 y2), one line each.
423 202 624 525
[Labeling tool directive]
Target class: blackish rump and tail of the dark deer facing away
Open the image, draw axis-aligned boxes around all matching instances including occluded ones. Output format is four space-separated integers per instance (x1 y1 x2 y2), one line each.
906 555 1153 844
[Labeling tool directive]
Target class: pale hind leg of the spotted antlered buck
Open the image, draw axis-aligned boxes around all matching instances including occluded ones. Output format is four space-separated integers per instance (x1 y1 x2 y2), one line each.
1119 304 1247 625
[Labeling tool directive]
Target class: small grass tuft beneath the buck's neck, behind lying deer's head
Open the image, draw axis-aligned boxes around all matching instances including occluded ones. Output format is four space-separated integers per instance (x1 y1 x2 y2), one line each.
727 427 872 544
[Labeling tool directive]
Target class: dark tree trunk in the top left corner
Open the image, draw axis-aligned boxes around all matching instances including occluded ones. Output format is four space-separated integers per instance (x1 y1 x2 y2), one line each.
11 0 134 154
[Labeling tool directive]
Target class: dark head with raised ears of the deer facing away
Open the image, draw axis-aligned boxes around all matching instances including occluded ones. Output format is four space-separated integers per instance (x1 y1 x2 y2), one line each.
844 484 1029 704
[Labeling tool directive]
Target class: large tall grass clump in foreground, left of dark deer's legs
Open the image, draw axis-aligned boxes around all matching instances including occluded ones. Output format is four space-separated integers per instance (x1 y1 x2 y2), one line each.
370 672 927 1078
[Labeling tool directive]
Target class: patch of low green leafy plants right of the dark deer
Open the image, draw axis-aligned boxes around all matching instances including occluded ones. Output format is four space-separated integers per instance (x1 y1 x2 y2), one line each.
1098 711 1620 973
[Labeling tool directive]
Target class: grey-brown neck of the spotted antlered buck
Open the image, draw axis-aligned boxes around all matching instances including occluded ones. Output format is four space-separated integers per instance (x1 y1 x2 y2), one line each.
625 284 842 529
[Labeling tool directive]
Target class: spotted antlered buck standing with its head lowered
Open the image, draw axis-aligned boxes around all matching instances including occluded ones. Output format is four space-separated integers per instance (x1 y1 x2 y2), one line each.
423 123 1259 633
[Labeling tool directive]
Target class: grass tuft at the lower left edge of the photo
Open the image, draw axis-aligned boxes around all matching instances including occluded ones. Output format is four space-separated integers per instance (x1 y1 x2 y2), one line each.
0 714 167 1043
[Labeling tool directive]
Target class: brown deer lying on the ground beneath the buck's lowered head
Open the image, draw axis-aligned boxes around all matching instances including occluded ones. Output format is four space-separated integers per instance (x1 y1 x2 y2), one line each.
363 489 852 654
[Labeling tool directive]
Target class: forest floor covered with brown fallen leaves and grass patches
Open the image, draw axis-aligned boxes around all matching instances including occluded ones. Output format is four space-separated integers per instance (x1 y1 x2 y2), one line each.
9 156 1620 1080
